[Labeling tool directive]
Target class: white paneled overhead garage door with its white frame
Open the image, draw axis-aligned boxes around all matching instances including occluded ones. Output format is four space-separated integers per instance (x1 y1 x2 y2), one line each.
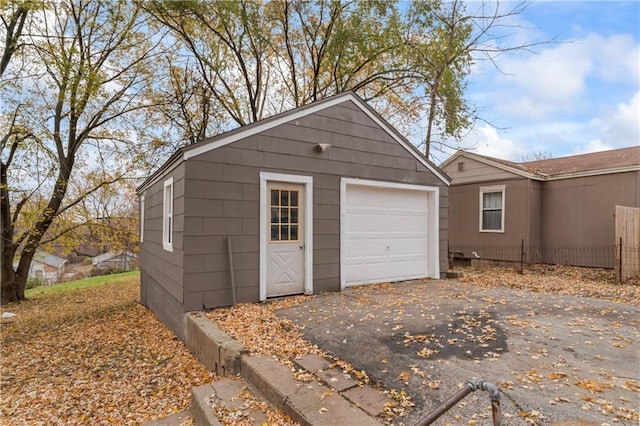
340 178 439 288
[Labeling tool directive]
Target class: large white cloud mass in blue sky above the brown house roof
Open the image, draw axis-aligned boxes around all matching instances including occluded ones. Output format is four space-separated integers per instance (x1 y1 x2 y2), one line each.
465 11 640 161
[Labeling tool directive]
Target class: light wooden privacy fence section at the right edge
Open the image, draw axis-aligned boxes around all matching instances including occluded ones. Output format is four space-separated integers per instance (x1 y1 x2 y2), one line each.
616 206 640 282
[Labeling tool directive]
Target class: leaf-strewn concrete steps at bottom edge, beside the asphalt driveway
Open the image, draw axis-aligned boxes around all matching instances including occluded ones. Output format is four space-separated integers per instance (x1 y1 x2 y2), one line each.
191 356 387 426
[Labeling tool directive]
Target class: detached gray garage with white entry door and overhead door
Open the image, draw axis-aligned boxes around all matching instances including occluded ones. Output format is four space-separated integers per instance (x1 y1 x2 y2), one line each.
138 92 449 336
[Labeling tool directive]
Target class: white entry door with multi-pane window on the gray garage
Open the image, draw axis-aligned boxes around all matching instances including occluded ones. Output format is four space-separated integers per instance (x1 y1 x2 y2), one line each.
266 182 305 297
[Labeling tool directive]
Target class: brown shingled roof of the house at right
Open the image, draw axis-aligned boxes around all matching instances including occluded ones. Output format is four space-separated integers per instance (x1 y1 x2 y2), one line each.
440 146 640 180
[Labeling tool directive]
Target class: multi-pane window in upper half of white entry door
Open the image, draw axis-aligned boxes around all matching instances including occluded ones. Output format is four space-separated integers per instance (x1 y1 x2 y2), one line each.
269 189 300 241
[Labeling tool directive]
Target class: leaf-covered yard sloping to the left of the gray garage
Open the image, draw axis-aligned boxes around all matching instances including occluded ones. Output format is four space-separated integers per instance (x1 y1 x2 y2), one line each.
0 276 213 425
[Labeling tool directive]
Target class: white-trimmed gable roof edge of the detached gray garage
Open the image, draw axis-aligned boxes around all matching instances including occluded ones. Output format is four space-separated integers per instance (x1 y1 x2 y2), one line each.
137 92 451 193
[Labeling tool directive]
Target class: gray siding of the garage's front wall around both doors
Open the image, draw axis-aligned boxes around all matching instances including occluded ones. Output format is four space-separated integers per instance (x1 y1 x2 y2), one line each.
184 103 448 310
